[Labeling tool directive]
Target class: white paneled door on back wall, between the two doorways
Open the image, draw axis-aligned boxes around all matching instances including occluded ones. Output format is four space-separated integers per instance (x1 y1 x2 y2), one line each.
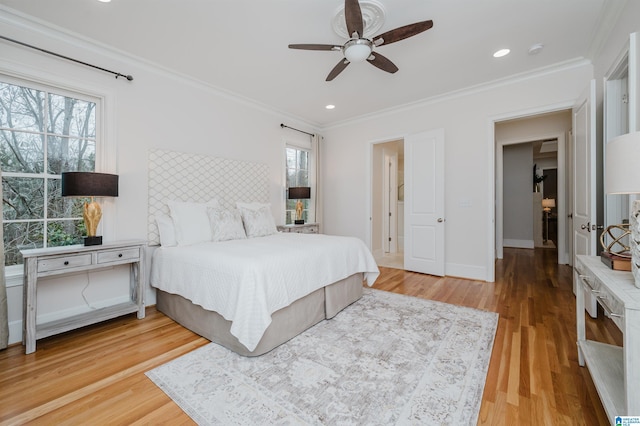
404 129 445 276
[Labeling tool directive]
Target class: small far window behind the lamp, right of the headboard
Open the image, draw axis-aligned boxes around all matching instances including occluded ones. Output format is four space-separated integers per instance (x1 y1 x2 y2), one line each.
285 146 314 224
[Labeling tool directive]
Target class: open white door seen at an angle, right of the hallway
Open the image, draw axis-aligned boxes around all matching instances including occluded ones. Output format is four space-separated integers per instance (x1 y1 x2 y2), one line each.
573 80 597 318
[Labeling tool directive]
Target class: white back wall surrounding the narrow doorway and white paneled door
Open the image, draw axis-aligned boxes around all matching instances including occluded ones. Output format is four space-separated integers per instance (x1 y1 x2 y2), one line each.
323 63 593 279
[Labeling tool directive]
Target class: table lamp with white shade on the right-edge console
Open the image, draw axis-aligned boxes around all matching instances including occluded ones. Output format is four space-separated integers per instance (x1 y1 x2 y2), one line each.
604 132 640 287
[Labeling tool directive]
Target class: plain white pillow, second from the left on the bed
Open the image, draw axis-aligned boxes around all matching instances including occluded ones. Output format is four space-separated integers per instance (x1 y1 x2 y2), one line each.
167 200 219 246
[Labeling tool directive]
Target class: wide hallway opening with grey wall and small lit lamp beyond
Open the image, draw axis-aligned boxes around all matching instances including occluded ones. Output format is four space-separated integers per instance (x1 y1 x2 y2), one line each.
494 109 572 264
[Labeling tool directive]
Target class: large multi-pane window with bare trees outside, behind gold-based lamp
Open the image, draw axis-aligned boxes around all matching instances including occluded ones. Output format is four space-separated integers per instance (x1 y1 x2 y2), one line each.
0 76 99 266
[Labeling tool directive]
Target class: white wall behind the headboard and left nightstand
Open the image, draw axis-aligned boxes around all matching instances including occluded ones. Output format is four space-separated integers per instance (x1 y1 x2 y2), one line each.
0 11 315 343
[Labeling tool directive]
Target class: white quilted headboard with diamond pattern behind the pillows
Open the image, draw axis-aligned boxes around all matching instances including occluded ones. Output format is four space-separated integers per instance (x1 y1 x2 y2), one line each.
147 149 269 245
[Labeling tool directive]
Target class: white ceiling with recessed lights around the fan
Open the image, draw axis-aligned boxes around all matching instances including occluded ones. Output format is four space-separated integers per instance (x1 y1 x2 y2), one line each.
0 0 625 128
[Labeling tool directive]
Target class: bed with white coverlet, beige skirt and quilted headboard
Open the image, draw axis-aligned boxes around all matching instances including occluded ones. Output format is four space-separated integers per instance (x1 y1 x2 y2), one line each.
149 150 379 356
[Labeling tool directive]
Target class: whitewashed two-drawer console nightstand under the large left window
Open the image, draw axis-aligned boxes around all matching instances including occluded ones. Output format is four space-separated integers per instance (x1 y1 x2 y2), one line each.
21 240 147 354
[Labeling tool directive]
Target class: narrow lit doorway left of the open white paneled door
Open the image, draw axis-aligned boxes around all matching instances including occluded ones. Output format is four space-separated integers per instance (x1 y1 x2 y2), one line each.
371 139 404 269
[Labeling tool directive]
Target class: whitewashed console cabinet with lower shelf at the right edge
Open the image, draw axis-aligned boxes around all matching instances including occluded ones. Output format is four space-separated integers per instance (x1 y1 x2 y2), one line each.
574 256 640 424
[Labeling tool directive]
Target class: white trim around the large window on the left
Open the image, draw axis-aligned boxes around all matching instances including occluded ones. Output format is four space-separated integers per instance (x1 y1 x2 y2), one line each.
0 67 116 287
